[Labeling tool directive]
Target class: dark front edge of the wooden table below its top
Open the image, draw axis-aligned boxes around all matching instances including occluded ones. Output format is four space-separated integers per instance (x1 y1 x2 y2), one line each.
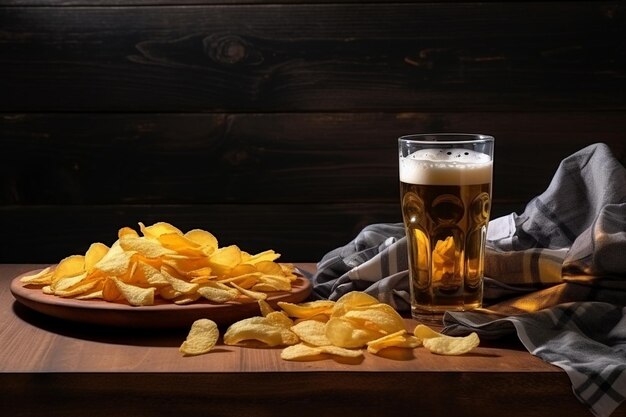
0 372 596 417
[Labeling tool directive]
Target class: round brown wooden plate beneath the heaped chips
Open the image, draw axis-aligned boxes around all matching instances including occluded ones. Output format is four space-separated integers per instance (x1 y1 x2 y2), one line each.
11 270 311 328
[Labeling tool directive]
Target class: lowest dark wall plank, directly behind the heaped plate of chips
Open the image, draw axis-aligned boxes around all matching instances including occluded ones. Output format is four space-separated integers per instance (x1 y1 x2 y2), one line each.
0 203 401 263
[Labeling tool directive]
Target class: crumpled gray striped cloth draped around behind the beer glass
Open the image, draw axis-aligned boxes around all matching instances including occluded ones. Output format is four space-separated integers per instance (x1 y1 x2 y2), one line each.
311 143 626 417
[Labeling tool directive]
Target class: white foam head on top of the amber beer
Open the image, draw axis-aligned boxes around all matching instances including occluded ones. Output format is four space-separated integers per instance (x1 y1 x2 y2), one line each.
400 148 493 185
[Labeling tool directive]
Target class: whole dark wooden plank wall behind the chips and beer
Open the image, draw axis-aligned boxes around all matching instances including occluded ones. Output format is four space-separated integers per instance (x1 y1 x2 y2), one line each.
0 0 626 262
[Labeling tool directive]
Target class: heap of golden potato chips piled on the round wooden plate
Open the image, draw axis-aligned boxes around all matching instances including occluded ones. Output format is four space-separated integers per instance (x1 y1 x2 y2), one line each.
21 222 297 306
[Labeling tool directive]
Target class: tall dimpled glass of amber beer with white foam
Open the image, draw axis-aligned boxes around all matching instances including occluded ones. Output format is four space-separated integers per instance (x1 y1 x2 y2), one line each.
398 133 494 322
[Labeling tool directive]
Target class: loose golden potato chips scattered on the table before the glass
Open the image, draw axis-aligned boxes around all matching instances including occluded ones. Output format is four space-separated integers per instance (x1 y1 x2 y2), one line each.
180 291 480 360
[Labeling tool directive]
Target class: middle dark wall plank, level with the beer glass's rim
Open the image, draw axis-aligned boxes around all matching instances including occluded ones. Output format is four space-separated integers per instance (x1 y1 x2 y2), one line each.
0 111 626 205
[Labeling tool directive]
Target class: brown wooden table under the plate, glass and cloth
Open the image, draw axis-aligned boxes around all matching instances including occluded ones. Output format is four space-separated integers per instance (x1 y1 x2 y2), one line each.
0 264 626 417
